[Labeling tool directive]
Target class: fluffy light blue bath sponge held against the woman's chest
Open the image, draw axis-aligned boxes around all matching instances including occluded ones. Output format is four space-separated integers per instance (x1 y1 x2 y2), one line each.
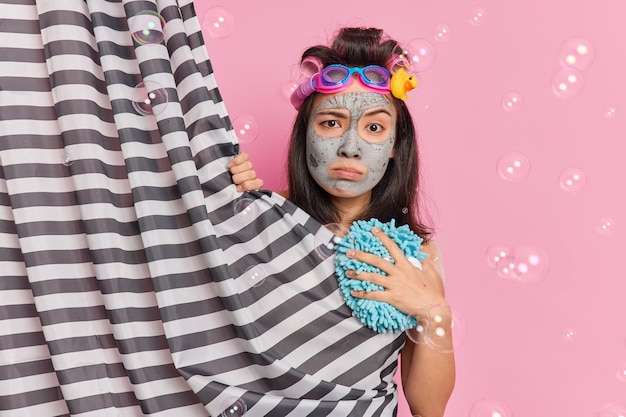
335 219 428 333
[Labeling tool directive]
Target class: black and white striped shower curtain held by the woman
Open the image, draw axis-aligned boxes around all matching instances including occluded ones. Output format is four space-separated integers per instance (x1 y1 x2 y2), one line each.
0 0 404 417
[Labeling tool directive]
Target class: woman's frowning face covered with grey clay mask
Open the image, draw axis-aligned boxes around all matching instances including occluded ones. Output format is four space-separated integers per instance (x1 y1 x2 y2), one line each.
306 83 396 197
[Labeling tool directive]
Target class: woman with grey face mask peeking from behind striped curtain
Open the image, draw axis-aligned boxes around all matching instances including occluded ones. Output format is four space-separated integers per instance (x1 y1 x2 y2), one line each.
230 28 455 417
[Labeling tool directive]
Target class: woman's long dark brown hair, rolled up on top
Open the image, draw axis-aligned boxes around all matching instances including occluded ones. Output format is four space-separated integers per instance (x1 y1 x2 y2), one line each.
287 28 432 240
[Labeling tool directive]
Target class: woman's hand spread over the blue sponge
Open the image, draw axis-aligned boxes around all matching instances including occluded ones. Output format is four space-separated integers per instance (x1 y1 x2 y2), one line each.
346 227 447 316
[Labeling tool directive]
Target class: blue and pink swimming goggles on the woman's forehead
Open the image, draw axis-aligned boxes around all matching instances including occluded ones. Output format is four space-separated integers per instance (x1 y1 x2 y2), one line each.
291 64 391 110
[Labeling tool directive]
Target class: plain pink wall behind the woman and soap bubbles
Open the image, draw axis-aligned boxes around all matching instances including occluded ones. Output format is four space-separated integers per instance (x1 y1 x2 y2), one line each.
196 0 626 417
